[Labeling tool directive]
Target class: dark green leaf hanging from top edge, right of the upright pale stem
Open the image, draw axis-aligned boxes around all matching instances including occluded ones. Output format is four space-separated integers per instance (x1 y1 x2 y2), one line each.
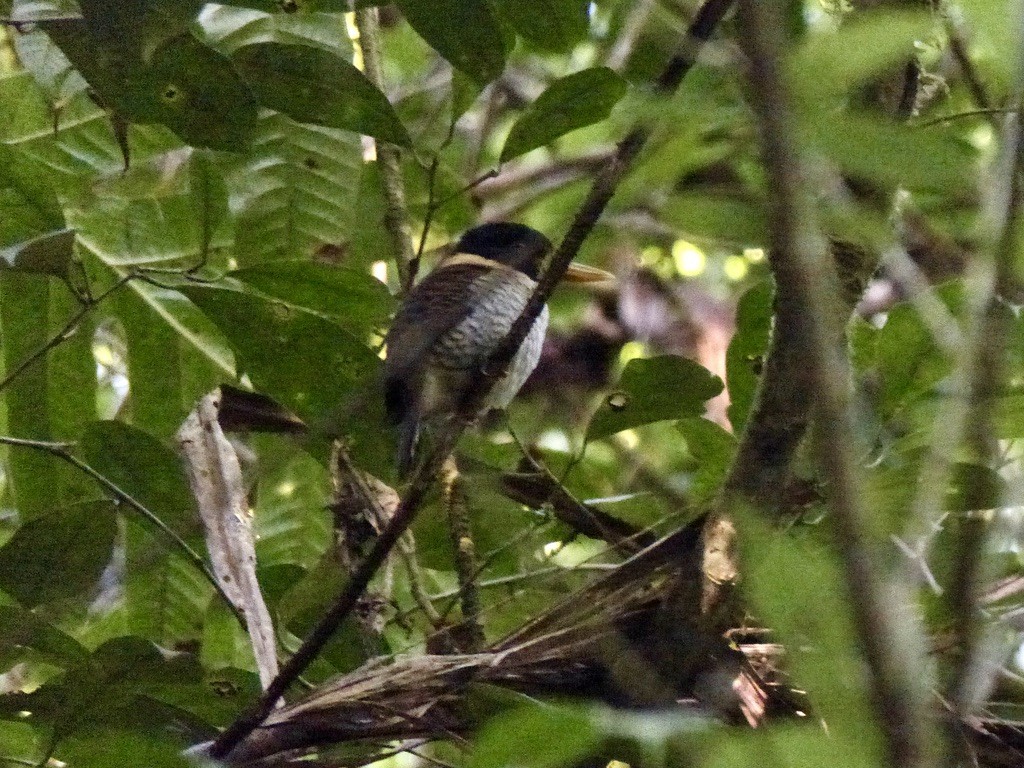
397 0 505 83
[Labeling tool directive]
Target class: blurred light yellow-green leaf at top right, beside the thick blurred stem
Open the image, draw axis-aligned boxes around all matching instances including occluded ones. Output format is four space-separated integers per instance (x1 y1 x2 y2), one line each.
787 10 935 104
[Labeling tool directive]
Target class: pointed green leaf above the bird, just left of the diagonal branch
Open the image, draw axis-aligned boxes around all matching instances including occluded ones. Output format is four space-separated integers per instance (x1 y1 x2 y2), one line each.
501 67 626 163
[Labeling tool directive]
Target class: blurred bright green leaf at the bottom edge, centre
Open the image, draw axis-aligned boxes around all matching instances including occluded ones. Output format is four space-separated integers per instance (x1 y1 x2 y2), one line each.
469 705 601 768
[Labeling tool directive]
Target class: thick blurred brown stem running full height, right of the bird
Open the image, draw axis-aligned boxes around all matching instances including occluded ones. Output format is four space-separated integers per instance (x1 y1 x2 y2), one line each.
739 0 934 768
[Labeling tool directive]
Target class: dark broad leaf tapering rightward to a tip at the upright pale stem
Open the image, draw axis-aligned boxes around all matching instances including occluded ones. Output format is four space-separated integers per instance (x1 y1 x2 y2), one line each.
231 43 412 146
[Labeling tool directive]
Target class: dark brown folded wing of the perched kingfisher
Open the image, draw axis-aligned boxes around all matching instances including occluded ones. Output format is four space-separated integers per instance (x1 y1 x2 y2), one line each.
384 263 493 424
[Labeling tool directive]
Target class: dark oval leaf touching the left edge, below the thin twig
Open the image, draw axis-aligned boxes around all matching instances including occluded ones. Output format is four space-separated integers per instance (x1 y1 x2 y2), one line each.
0 501 118 608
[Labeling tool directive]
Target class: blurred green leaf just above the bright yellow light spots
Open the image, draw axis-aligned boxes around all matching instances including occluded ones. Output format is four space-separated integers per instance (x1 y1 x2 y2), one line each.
662 191 767 246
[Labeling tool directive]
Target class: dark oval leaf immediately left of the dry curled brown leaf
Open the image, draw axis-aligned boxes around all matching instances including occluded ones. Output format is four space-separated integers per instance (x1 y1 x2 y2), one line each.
80 421 199 536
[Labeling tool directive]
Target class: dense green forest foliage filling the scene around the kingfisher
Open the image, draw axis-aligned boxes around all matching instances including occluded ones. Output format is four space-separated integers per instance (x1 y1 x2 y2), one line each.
0 0 1024 768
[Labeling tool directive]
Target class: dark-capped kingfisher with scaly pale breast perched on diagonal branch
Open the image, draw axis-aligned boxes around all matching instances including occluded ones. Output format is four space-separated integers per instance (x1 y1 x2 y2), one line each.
384 221 614 477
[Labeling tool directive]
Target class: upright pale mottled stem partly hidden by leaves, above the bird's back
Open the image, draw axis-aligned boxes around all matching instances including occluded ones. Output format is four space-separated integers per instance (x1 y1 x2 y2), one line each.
355 8 417 296
